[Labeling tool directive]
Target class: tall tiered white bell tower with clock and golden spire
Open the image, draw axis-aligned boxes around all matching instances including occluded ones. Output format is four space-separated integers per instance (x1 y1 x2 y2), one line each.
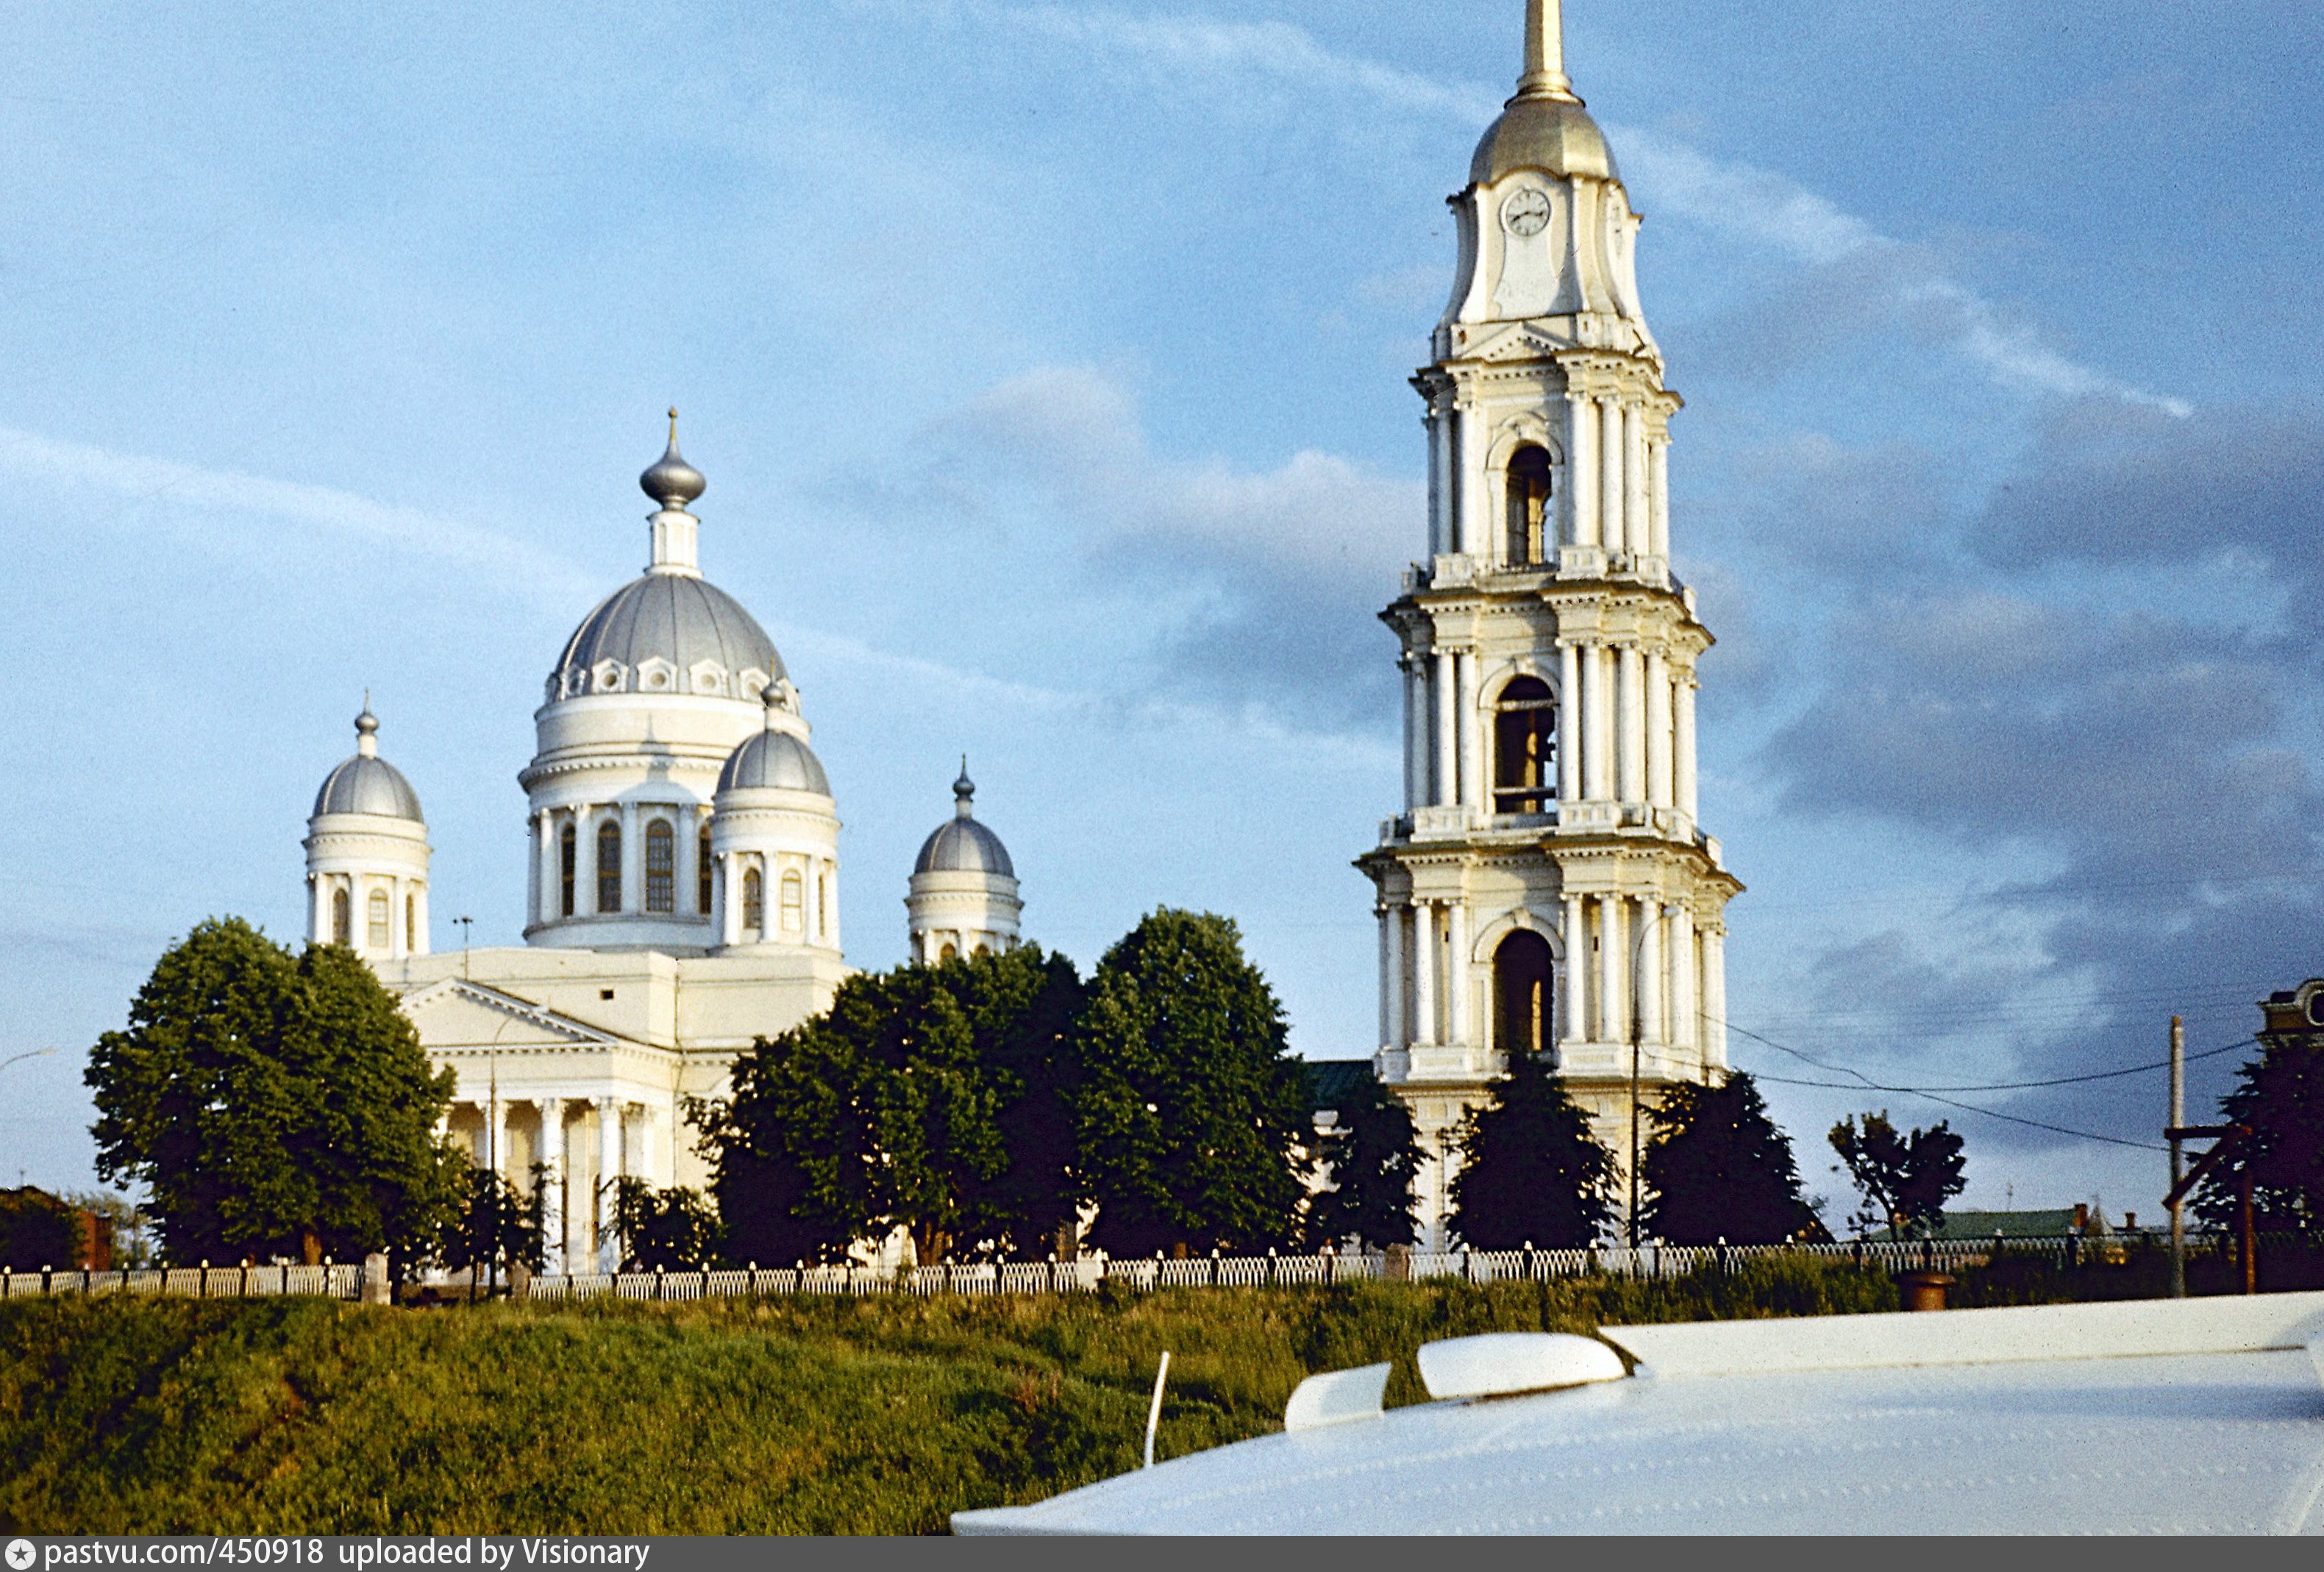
1357 0 1743 1246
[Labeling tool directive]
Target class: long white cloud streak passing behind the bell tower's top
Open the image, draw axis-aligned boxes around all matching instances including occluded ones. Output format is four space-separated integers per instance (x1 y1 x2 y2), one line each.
910 0 2192 416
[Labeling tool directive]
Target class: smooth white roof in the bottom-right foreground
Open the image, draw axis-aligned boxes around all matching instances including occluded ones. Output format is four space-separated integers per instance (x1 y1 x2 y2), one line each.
953 1293 2324 1534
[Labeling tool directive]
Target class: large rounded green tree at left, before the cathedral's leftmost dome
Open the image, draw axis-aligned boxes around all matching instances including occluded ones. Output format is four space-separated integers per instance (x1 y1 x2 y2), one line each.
86 919 463 1260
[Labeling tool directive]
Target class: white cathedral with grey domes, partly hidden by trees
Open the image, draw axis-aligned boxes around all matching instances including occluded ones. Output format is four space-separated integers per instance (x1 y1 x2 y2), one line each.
307 412 1022 1272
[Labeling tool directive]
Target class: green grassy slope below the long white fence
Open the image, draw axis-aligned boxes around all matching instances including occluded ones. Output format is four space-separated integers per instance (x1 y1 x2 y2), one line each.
0 1260 1897 1532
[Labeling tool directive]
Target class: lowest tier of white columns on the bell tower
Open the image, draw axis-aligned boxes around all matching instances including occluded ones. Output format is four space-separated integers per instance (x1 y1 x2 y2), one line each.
1376 895 1727 1063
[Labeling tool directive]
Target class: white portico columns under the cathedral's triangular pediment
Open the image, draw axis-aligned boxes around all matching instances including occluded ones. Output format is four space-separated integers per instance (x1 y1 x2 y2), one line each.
446 1095 674 1272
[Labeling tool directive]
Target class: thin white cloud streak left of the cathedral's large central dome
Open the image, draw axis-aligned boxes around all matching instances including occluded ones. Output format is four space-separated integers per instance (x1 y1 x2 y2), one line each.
0 428 593 605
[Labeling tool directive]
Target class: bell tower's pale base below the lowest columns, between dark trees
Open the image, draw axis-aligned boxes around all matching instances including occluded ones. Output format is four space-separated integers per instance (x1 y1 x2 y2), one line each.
1374 1042 1719 1251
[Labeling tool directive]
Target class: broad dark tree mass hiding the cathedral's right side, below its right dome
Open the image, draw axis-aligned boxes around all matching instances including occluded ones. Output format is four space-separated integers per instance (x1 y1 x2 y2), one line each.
695 944 1080 1260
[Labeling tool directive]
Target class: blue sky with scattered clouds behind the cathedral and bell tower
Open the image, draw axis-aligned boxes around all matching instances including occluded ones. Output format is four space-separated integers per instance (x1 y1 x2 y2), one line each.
0 0 2324 1216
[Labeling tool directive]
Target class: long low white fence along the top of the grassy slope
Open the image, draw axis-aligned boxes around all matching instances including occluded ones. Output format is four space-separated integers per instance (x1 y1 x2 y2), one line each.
0 1237 2184 1300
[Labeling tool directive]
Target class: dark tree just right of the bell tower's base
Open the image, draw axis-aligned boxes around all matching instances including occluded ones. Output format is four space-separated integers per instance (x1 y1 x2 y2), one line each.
1639 1070 1825 1244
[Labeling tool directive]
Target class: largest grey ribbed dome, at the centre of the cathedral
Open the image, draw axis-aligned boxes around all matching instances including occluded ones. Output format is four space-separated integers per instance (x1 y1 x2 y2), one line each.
555 572 783 700
